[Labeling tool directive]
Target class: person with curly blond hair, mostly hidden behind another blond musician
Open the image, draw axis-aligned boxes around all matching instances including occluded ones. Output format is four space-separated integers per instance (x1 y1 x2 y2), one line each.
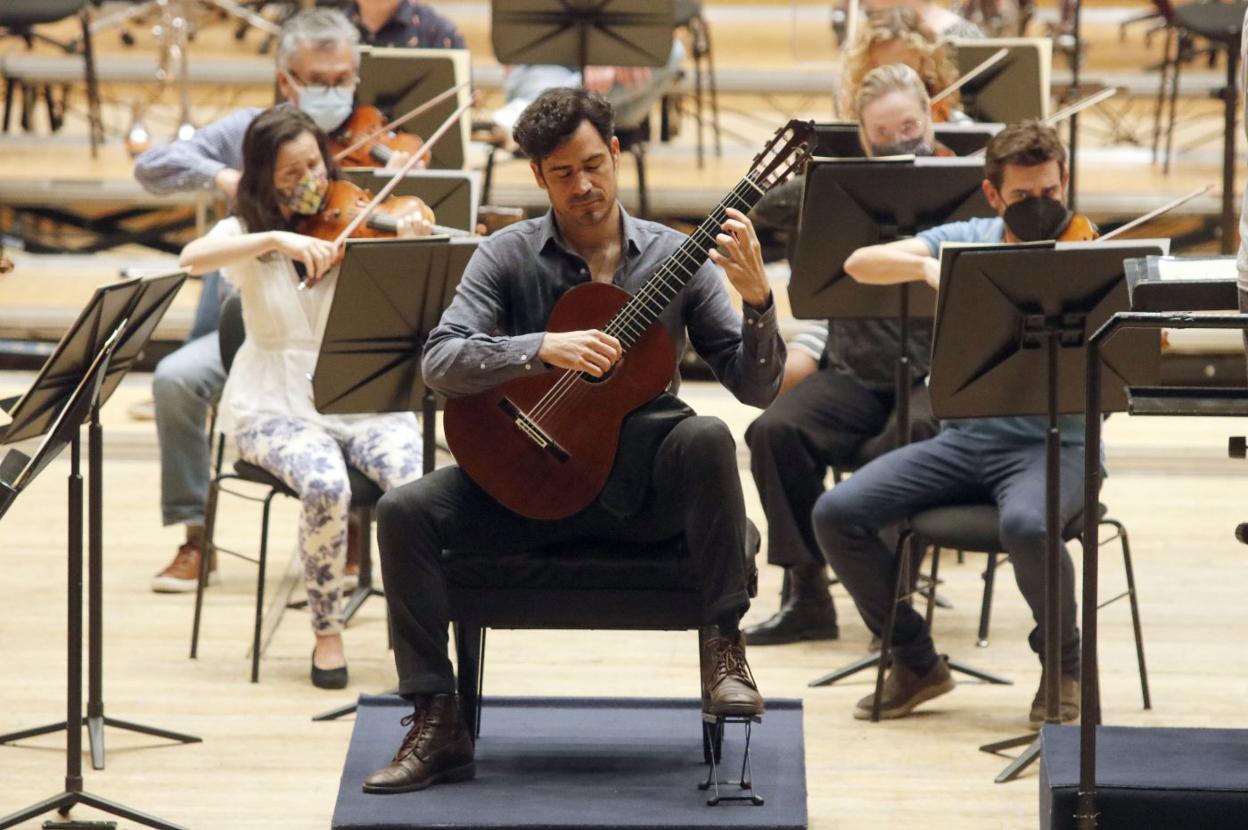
835 7 968 121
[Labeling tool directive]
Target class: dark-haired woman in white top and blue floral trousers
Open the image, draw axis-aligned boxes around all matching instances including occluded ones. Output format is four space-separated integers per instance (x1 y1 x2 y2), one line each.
173 105 429 689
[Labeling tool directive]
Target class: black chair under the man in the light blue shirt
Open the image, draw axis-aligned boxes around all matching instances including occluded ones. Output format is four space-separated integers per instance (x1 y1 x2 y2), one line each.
871 504 1152 720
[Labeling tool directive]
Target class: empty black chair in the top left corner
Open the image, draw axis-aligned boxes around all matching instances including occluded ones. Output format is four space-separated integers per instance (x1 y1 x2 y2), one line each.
0 0 104 152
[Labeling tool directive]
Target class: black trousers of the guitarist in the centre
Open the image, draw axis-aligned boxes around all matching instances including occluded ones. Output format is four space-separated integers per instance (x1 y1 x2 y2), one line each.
377 417 750 695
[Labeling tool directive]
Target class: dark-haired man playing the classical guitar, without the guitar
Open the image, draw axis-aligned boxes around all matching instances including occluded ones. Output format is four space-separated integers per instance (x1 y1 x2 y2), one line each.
363 89 784 793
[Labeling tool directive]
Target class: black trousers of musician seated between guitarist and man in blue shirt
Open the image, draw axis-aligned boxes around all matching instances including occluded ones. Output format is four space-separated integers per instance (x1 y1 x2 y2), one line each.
745 368 937 568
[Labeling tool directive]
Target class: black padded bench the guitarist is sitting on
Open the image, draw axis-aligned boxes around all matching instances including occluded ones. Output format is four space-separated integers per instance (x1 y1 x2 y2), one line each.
443 523 760 749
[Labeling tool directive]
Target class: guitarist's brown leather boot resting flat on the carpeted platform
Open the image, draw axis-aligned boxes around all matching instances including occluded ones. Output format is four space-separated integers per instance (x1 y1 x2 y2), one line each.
364 694 477 794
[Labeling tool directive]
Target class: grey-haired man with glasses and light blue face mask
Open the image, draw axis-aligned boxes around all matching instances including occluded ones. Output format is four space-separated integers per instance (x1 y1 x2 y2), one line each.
135 9 431 593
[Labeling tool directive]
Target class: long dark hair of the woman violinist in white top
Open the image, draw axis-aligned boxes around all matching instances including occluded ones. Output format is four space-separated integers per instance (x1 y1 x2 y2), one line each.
235 104 341 233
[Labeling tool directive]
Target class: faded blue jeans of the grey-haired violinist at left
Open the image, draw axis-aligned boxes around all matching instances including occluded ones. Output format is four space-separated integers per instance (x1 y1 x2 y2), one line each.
152 332 226 524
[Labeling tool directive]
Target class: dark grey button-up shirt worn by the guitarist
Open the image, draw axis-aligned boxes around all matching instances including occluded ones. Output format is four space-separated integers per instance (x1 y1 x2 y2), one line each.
422 206 785 407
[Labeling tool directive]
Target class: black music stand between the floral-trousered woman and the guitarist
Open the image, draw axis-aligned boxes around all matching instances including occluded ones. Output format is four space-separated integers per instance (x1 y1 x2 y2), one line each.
312 237 479 720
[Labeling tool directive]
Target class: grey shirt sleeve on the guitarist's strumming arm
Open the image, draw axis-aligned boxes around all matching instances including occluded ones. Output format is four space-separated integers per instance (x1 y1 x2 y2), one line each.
421 247 545 396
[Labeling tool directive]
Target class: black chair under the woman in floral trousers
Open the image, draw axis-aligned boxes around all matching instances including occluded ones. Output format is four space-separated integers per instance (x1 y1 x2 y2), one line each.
191 296 382 683
